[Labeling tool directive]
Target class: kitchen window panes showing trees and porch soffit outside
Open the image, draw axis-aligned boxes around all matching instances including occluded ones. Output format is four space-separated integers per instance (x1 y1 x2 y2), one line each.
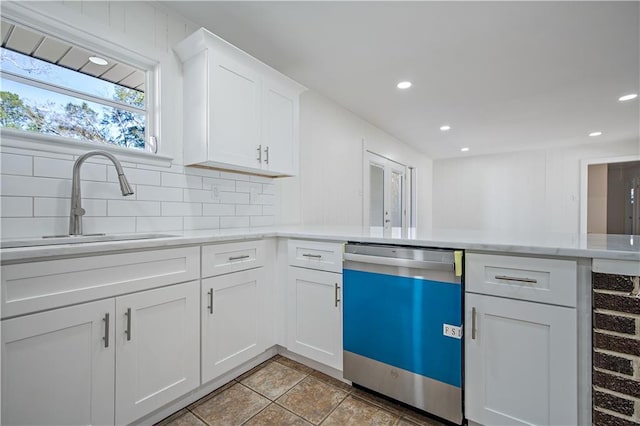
0 21 157 152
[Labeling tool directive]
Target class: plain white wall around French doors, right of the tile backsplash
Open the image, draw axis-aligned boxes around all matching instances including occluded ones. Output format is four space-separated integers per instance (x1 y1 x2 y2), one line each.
276 91 432 229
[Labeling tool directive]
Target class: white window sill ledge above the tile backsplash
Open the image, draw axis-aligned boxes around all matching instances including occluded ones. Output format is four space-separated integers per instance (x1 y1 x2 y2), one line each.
0 128 173 168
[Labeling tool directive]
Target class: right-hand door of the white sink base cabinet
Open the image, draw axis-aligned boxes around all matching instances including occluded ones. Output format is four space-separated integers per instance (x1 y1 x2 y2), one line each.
116 281 200 424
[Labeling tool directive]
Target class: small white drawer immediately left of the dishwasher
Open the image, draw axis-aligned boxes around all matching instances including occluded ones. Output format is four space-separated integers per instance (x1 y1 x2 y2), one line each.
289 240 344 273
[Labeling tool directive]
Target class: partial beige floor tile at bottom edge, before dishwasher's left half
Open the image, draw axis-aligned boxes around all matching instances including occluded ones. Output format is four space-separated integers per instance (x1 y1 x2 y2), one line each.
322 396 398 426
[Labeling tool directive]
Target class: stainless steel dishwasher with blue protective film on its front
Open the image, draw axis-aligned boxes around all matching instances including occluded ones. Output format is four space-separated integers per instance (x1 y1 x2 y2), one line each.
343 243 463 424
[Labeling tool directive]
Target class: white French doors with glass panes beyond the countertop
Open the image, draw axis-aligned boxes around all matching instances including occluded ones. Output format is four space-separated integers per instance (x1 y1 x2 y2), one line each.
364 152 408 236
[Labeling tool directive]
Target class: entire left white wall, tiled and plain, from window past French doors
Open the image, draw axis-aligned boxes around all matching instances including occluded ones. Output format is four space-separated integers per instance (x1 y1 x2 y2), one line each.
0 1 431 238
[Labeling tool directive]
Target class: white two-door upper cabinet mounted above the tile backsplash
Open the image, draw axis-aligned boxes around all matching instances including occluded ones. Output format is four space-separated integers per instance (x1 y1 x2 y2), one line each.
175 28 305 176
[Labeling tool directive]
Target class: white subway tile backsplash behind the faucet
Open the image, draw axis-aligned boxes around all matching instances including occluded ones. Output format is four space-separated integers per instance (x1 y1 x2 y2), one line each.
0 147 276 238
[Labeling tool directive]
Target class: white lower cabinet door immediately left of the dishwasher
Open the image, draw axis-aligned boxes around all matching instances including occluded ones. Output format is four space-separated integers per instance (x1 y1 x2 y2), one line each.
287 266 342 370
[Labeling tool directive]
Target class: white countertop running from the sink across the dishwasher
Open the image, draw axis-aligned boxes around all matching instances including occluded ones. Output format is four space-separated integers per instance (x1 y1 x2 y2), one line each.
0 226 640 263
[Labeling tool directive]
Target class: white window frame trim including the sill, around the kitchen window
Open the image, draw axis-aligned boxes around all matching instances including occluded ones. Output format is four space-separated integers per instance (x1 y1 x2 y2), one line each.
0 2 173 166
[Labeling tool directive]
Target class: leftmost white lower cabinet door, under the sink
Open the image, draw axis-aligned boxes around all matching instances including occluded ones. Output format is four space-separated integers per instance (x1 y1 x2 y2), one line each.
2 299 115 425
